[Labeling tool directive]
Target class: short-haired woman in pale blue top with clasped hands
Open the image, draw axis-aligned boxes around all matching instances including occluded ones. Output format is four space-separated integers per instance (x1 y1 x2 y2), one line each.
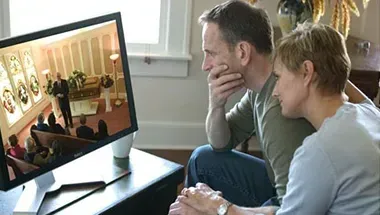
170 23 380 215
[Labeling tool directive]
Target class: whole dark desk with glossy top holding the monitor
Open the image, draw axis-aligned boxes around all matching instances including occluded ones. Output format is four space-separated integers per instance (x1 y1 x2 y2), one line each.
0 146 184 215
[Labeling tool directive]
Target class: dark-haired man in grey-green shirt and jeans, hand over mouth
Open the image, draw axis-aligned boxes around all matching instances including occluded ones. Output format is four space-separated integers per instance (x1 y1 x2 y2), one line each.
171 1 315 214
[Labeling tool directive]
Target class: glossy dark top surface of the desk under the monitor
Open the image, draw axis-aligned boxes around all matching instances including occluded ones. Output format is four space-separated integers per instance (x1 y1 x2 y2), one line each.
0 145 184 214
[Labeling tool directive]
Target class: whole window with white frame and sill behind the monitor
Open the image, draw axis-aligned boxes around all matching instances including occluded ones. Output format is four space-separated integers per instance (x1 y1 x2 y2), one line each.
0 0 192 77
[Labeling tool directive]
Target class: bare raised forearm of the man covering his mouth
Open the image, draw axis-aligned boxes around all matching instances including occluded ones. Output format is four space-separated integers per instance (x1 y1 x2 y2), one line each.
206 107 231 149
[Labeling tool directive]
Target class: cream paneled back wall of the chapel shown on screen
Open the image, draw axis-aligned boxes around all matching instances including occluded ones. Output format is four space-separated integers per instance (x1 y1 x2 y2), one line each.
41 22 125 98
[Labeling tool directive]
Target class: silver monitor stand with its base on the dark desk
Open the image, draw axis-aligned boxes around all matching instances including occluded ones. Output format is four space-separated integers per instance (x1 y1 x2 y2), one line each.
13 144 131 215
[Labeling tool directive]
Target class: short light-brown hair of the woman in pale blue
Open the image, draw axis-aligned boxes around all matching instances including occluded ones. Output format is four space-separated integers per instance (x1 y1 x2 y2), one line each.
274 22 351 94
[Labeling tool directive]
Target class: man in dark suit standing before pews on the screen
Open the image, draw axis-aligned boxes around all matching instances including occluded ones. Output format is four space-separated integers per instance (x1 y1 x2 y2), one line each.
53 72 73 128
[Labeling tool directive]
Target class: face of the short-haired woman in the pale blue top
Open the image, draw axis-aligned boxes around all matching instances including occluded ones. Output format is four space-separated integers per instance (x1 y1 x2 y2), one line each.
273 58 307 118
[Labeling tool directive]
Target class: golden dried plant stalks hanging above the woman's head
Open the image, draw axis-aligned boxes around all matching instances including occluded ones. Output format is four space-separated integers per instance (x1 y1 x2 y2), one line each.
247 0 370 38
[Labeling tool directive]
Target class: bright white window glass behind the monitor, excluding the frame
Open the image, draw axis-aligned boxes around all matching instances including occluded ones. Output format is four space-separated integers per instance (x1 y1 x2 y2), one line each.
9 0 161 44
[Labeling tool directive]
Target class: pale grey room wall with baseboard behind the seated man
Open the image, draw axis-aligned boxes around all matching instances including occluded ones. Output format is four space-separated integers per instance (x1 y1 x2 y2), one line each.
132 0 380 149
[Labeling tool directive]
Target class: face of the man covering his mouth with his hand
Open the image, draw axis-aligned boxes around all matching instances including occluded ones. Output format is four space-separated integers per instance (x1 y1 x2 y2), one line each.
202 23 240 73
